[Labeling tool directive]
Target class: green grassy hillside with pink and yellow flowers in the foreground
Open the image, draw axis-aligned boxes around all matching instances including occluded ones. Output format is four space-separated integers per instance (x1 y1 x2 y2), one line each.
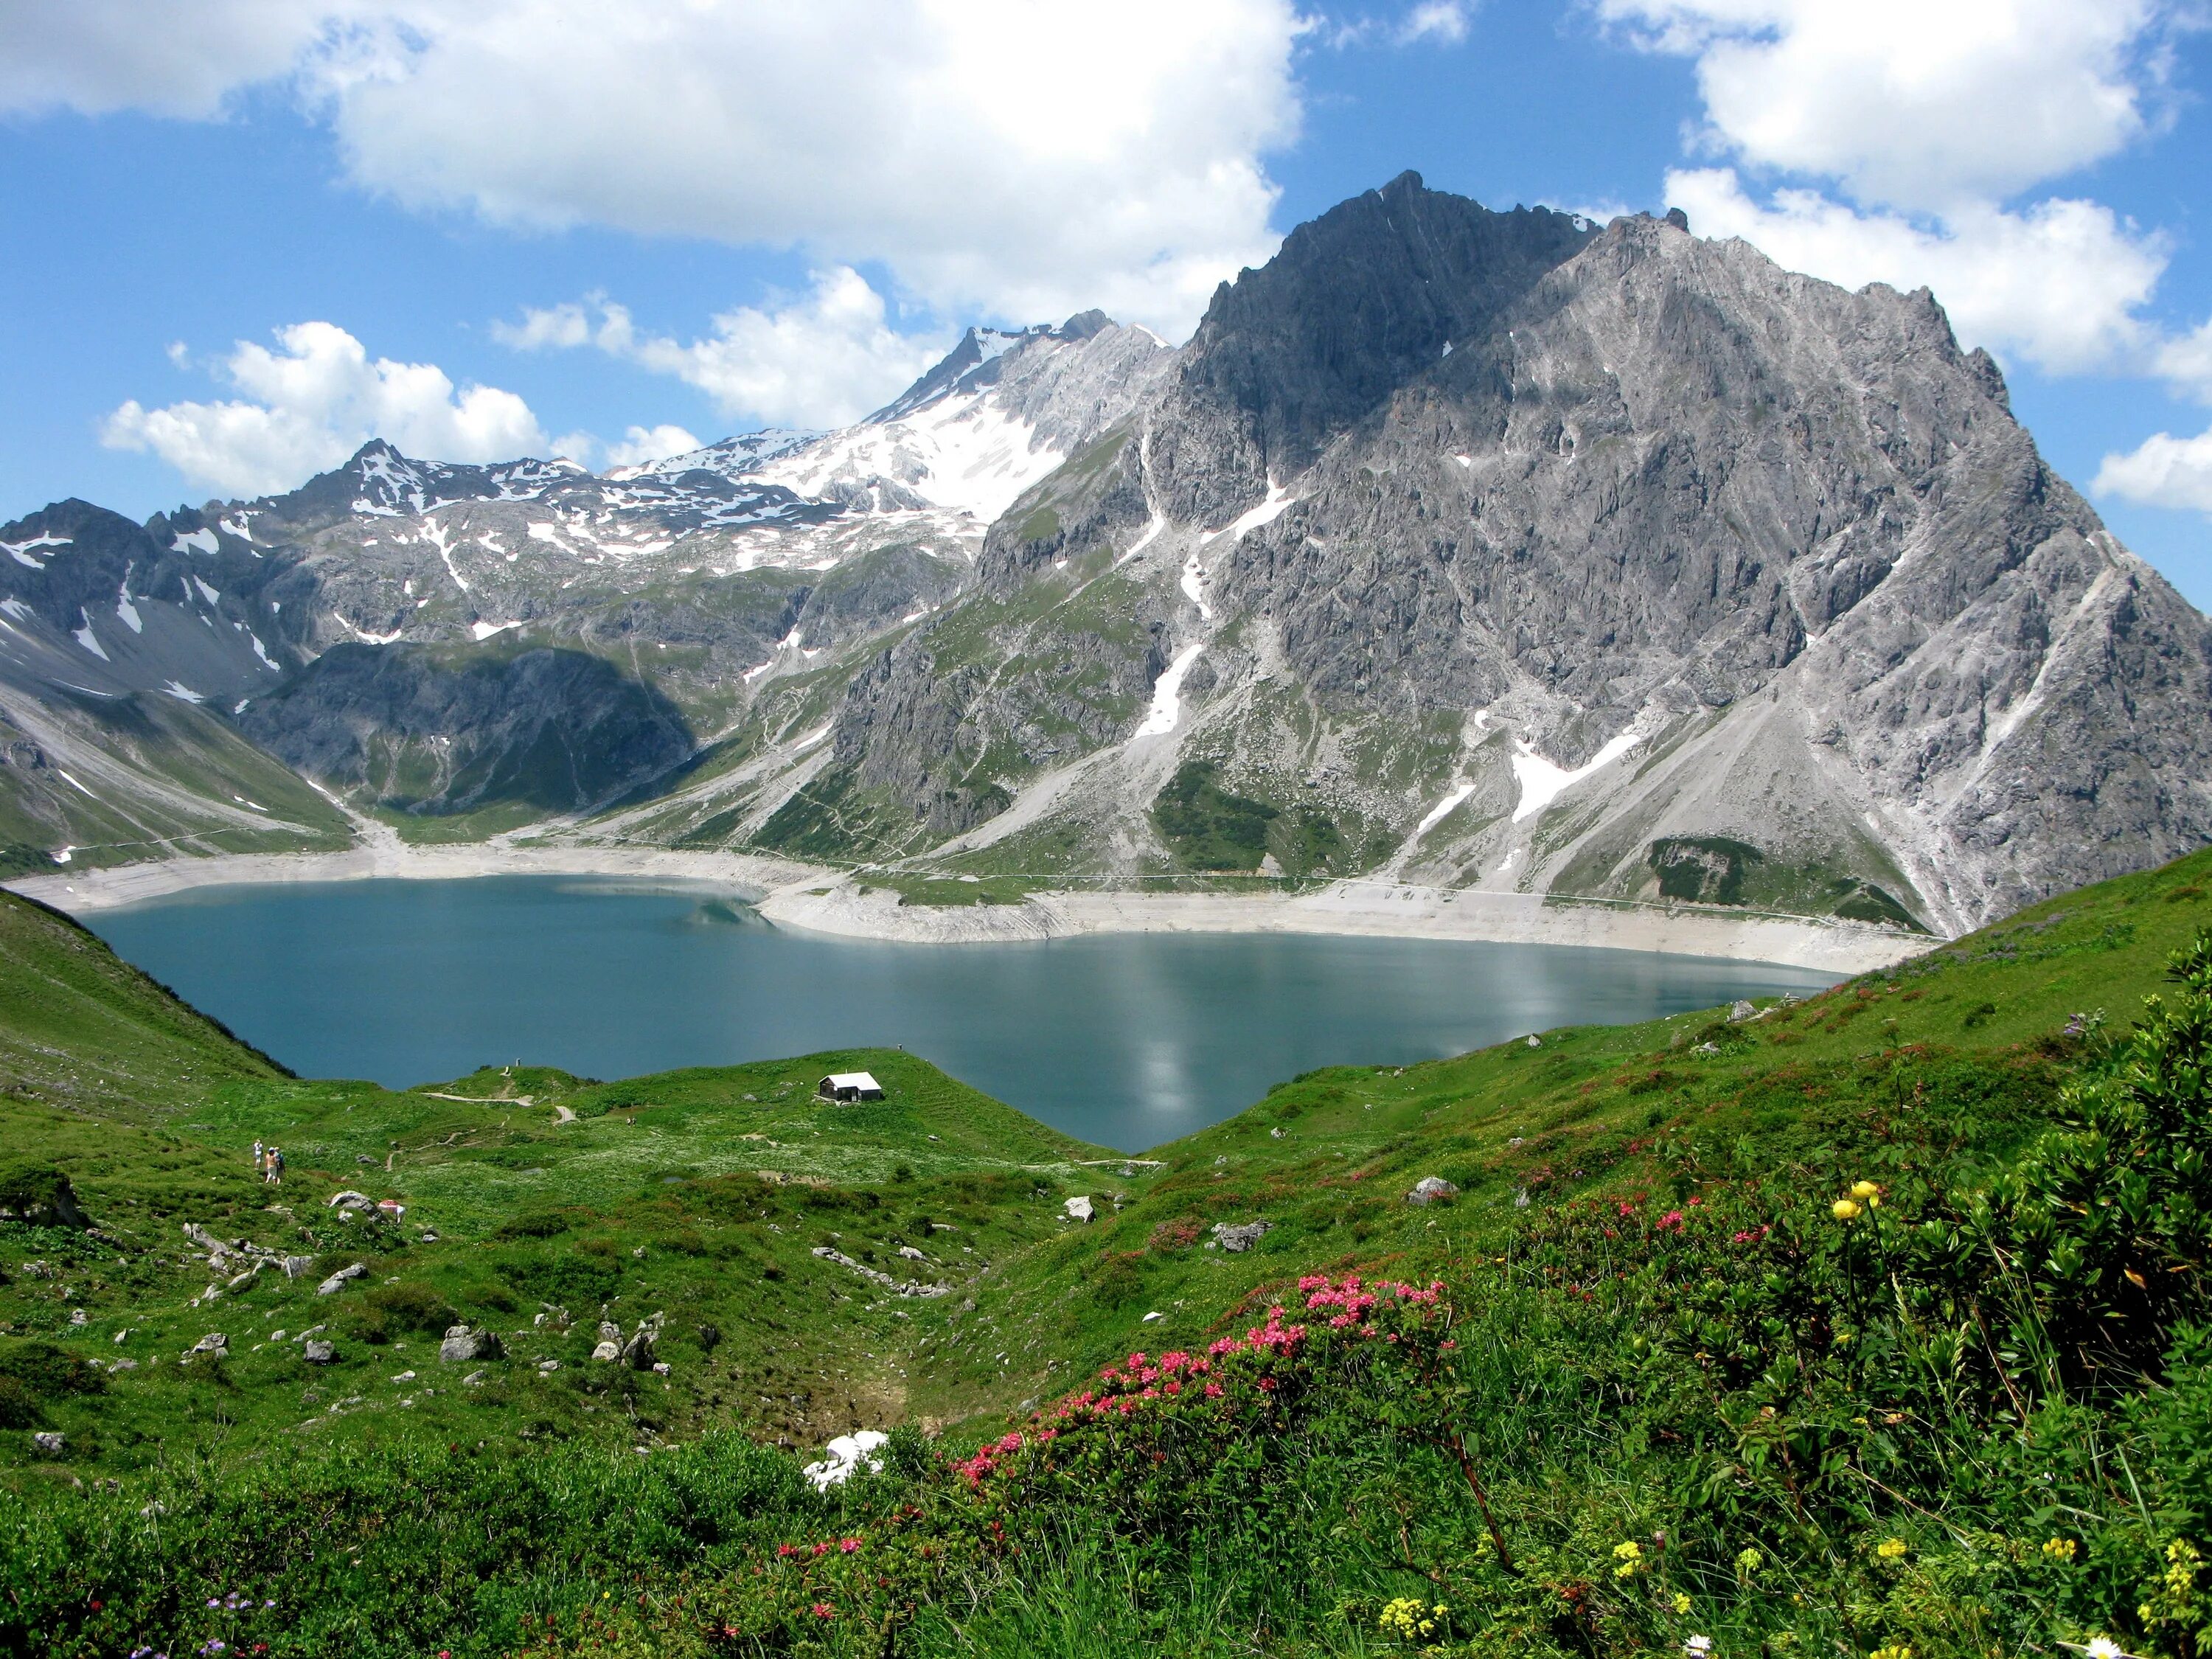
0 854 2212 1659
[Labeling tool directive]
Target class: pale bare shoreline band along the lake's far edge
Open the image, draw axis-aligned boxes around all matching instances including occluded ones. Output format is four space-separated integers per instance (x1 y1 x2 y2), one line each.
4 834 1942 975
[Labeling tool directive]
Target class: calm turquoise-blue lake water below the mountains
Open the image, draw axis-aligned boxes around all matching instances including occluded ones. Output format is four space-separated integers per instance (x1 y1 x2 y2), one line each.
88 876 1836 1150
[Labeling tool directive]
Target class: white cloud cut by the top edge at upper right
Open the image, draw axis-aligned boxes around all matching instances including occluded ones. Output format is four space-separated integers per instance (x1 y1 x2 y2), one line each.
1599 0 2174 212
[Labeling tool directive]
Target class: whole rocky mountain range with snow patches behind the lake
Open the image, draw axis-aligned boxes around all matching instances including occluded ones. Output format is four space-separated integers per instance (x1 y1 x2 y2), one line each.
0 175 2212 933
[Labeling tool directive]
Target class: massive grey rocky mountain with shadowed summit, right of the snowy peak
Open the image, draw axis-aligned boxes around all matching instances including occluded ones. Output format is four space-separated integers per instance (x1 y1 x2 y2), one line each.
814 177 2212 931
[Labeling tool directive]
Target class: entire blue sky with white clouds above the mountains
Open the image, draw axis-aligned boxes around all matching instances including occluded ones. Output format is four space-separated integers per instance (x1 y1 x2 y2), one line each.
0 0 2212 608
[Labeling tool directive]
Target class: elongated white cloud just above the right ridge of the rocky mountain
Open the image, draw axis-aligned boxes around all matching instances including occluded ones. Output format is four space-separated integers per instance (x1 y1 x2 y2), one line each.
1666 168 2166 374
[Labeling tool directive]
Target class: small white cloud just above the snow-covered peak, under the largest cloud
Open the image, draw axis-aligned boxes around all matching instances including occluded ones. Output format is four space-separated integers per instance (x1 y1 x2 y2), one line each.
493 265 951 431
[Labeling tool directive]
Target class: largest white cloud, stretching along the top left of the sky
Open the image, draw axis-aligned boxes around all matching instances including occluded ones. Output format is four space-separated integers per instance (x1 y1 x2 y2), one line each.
0 0 1301 334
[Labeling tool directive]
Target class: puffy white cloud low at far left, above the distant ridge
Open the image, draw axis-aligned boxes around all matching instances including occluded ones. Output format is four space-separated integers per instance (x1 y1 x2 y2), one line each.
100 323 546 495
